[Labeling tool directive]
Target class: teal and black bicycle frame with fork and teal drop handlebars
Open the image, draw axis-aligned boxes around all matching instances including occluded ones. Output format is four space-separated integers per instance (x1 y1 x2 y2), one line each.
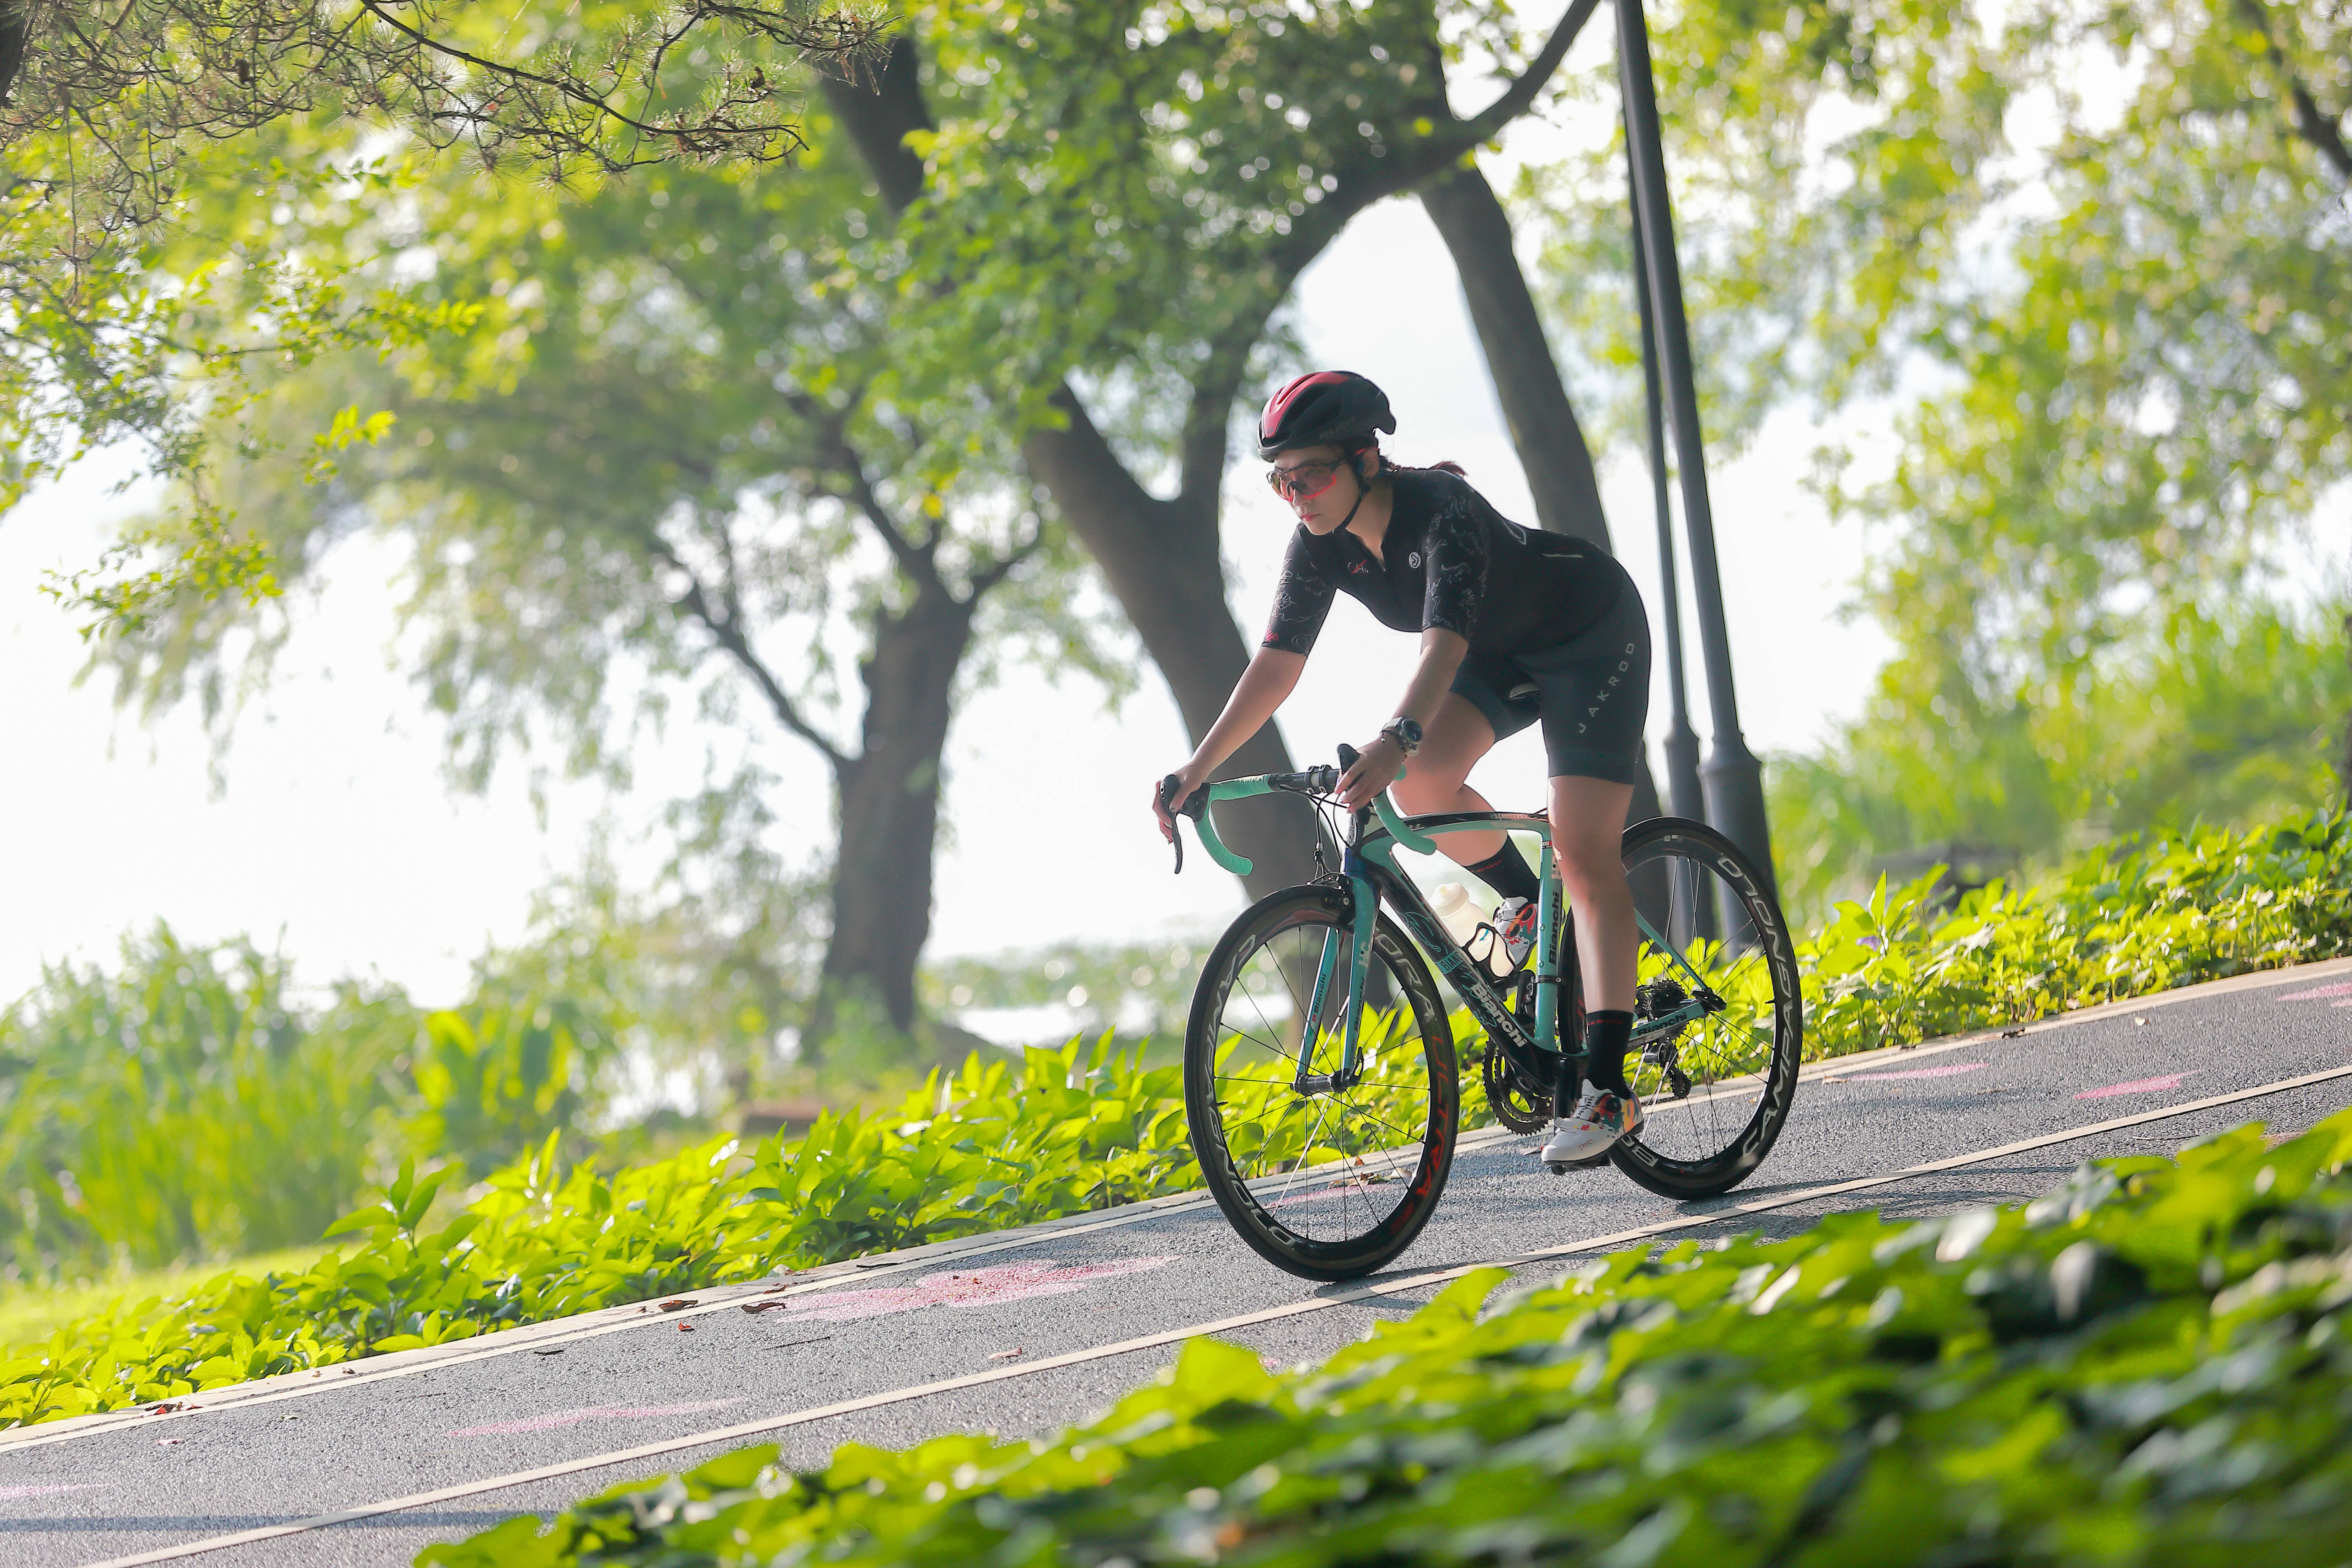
1192 774 1724 1093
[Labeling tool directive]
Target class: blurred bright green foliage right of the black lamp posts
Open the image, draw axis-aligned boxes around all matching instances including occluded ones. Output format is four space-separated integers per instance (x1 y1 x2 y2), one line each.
1522 0 2352 921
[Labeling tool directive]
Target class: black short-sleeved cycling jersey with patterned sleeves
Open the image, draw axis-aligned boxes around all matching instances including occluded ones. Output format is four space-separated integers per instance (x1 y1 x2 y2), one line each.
1263 468 1630 656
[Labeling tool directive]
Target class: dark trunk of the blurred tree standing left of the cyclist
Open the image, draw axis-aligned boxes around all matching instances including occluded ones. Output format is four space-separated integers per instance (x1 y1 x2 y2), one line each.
807 580 976 1039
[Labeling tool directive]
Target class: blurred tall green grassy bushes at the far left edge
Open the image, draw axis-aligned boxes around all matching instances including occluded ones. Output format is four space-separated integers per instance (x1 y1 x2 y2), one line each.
0 924 628 1281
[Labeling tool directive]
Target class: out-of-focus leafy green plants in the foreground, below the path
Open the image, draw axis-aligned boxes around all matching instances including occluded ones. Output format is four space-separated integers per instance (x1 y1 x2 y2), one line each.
419 1112 2352 1568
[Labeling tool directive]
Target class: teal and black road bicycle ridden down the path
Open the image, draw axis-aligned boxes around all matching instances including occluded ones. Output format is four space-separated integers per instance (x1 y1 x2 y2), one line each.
1162 748 1804 1279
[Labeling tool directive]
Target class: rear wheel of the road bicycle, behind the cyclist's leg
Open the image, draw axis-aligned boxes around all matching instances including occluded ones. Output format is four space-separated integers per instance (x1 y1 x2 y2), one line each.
1609 816 1804 1199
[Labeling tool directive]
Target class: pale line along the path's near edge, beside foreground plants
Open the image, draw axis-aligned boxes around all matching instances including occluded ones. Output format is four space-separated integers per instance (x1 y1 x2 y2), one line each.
73 1067 2352 1568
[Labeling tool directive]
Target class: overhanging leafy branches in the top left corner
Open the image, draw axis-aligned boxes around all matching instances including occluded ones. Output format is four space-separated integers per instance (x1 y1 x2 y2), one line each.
0 0 889 630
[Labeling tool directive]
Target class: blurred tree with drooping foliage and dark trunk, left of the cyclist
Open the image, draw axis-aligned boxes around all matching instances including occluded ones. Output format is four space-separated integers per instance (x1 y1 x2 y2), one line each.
92 120 1127 1072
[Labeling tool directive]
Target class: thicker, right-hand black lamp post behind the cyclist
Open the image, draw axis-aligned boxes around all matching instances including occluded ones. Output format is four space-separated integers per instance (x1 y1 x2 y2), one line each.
1616 0 1776 882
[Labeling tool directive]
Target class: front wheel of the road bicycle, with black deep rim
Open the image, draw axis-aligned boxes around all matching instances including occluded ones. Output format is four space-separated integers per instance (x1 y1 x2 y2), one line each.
1183 884 1461 1281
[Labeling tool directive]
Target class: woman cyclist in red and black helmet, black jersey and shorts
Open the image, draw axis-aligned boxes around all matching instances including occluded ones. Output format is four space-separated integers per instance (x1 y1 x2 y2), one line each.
1153 371 1649 1161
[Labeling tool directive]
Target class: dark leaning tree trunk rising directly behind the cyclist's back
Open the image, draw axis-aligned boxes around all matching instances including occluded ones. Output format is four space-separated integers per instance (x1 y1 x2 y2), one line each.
1421 165 1609 550
